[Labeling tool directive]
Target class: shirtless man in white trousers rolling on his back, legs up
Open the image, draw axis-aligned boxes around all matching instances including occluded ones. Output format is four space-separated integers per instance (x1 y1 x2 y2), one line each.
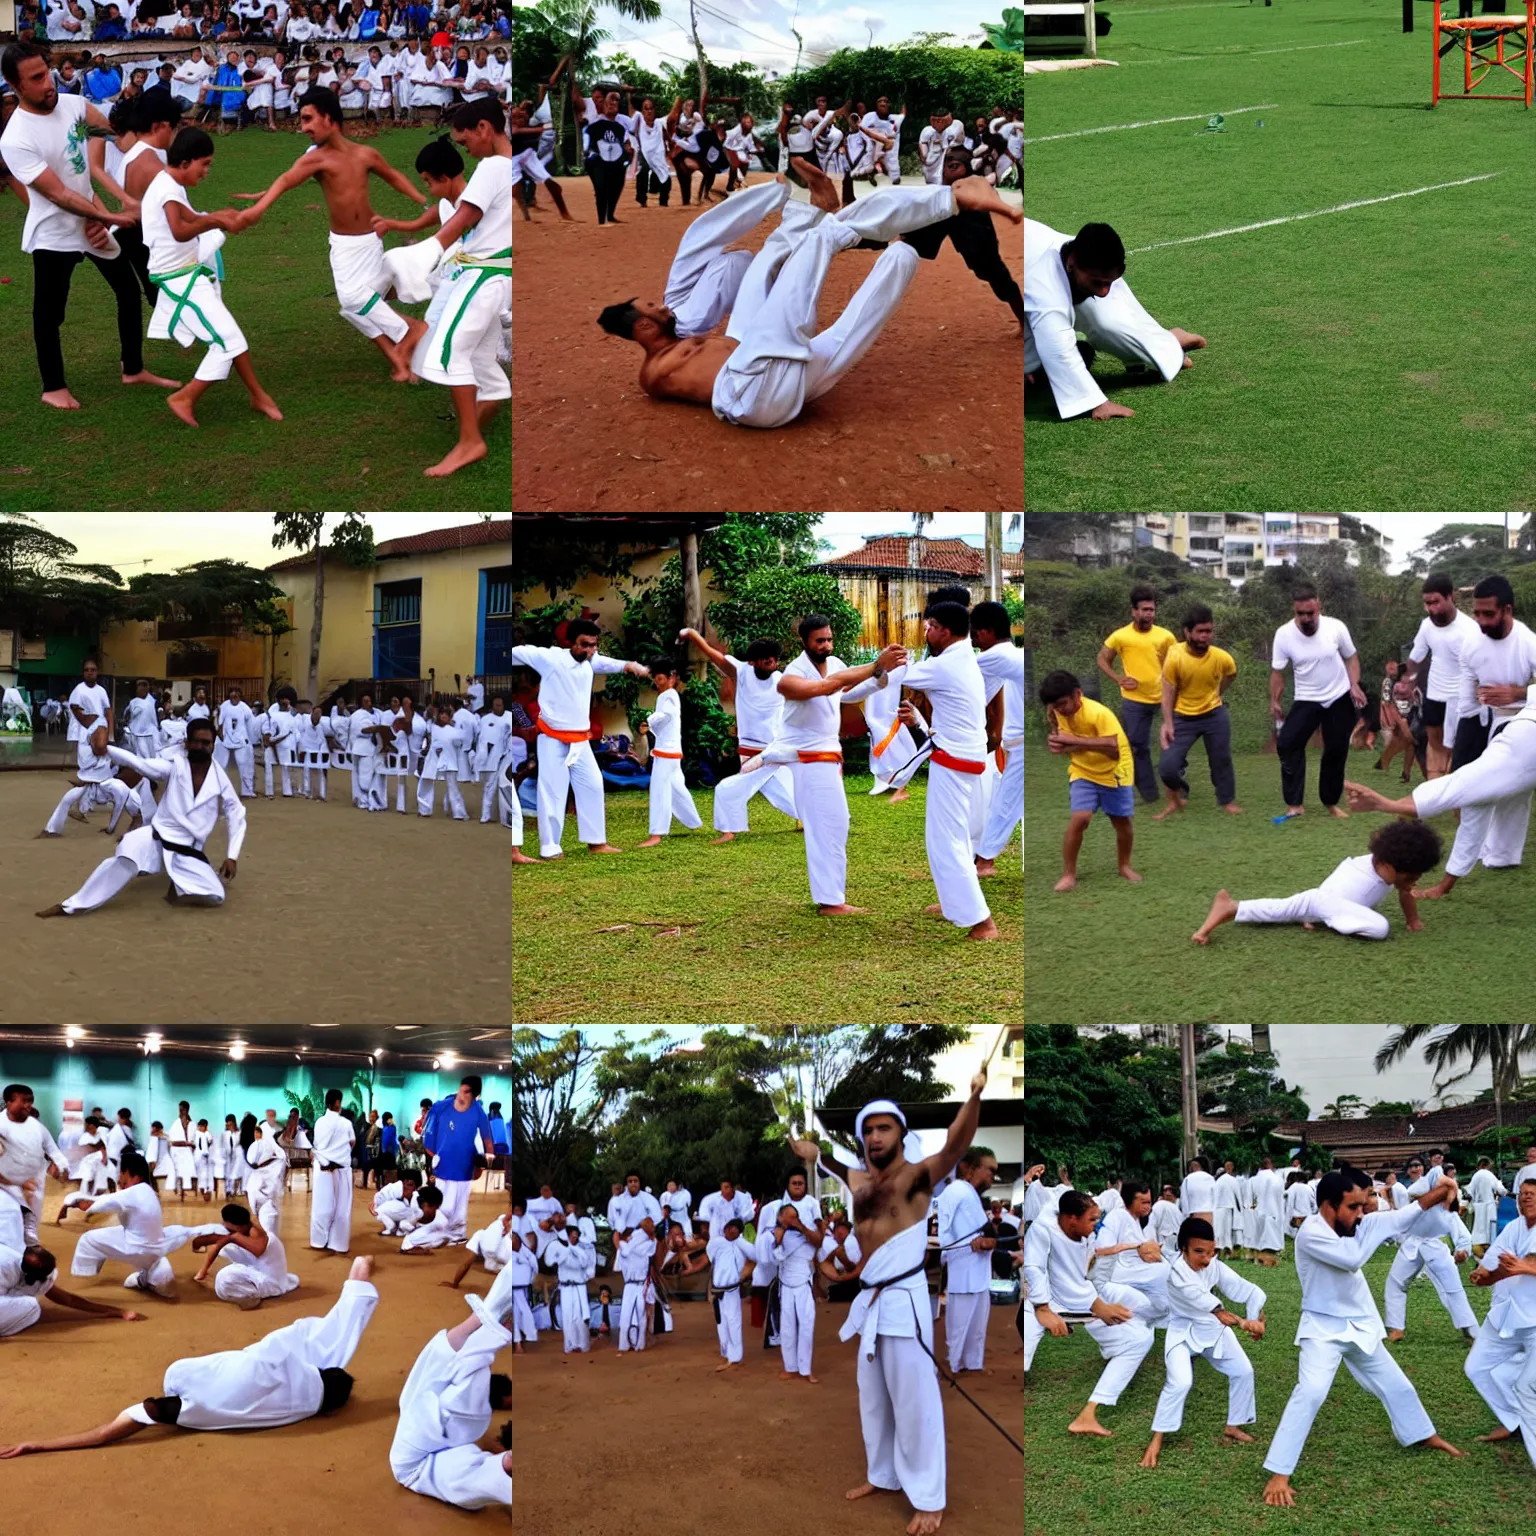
598 155 1023 427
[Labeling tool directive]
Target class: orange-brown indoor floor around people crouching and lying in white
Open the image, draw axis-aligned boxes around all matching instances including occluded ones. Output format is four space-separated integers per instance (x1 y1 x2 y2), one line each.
0 1177 510 1536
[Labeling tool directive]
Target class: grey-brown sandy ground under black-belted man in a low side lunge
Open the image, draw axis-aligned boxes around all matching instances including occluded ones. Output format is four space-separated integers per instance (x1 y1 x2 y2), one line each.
0 771 511 1025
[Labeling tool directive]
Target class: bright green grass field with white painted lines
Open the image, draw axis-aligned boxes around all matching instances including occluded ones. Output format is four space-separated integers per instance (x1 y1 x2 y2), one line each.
1025 0 1536 511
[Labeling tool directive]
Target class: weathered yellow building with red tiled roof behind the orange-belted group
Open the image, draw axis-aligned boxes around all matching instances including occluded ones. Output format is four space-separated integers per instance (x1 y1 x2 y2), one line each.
811 533 1025 651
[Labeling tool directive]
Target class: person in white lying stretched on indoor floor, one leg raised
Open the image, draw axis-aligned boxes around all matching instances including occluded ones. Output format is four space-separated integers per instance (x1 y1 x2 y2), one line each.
0 1253 379 1458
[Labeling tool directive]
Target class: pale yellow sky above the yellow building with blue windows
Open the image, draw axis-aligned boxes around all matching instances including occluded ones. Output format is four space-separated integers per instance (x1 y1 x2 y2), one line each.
19 511 497 581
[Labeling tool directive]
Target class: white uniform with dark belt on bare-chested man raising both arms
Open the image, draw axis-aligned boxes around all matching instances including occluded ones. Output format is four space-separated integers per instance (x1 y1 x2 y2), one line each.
839 1221 946 1510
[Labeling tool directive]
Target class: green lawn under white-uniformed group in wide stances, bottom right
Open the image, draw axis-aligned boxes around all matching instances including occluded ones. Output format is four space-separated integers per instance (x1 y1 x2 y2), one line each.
1025 1246 1536 1536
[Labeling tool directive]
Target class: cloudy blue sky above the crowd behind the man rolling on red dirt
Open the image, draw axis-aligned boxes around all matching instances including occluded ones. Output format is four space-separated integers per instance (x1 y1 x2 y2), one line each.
513 0 1003 84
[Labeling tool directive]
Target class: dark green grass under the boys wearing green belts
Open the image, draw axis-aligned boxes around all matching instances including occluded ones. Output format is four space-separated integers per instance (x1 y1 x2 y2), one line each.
0 127 511 511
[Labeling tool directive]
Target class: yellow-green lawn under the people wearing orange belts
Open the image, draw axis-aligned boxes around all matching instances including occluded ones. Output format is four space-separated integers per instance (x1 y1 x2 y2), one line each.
511 774 1023 1025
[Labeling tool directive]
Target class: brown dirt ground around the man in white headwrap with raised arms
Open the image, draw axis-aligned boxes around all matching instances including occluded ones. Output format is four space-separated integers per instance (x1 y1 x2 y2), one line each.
511 1301 1025 1536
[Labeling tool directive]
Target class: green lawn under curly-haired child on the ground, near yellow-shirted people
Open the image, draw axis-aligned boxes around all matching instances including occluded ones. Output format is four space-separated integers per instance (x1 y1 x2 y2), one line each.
1025 746 1536 1025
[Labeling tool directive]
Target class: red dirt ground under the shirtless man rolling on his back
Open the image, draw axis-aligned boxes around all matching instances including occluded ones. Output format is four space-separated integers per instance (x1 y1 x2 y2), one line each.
511 177 1025 511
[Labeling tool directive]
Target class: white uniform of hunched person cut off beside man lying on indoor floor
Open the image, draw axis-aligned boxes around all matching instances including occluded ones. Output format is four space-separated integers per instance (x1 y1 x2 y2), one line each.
389 1303 511 1510
